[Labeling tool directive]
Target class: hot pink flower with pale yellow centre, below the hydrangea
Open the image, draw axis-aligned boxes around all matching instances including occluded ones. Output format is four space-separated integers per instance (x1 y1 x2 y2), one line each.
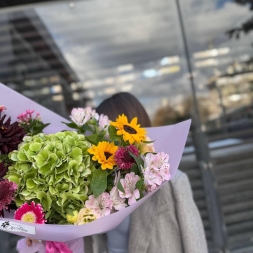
14 201 46 224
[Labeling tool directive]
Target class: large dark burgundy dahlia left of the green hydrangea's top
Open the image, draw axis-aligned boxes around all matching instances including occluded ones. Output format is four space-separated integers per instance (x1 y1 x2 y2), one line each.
0 115 26 154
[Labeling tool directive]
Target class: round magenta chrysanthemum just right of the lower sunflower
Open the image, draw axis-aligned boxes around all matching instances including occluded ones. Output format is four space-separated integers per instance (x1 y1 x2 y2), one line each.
114 145 139 170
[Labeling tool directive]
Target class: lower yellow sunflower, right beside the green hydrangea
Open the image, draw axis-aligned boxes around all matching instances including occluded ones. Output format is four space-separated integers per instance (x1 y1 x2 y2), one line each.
88 141 118 170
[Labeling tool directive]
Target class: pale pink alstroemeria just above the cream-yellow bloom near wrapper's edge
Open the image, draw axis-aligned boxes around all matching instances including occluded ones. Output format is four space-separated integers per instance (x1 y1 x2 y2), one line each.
85 192 113 218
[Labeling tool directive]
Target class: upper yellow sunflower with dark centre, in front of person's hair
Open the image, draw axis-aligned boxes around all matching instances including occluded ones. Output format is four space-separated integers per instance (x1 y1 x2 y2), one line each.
111 114 147 145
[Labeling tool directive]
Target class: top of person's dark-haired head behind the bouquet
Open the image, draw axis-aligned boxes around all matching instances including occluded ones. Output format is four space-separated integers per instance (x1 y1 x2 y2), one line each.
96 92 151 127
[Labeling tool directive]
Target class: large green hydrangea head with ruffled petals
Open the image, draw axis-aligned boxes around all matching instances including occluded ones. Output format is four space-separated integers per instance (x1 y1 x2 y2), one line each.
6 131 94 223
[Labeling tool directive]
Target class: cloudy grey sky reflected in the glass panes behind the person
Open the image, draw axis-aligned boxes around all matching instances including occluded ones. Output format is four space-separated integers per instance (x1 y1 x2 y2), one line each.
35 0 253 116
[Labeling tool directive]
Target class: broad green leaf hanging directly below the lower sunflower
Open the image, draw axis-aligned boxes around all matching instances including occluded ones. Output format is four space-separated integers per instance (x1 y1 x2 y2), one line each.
90 169 108 198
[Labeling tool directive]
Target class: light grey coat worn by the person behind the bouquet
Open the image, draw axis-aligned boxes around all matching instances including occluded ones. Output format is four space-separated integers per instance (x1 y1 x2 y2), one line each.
85 171 208 253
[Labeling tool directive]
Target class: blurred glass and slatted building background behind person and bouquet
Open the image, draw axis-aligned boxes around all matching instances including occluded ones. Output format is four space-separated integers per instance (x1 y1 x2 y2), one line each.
0 0 253 253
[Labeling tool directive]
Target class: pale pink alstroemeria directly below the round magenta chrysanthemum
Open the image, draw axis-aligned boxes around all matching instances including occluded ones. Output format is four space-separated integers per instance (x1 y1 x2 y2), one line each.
119 172 140 205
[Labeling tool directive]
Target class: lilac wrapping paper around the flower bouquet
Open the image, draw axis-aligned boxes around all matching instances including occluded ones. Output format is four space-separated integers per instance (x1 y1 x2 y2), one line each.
0 84 191 242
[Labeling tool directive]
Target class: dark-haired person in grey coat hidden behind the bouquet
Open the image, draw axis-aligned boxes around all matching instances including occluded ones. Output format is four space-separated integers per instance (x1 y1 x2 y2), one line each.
85 92 208 253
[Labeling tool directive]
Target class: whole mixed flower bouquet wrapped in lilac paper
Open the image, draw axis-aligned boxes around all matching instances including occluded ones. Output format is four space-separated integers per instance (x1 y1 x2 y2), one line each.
0 84 190 252
